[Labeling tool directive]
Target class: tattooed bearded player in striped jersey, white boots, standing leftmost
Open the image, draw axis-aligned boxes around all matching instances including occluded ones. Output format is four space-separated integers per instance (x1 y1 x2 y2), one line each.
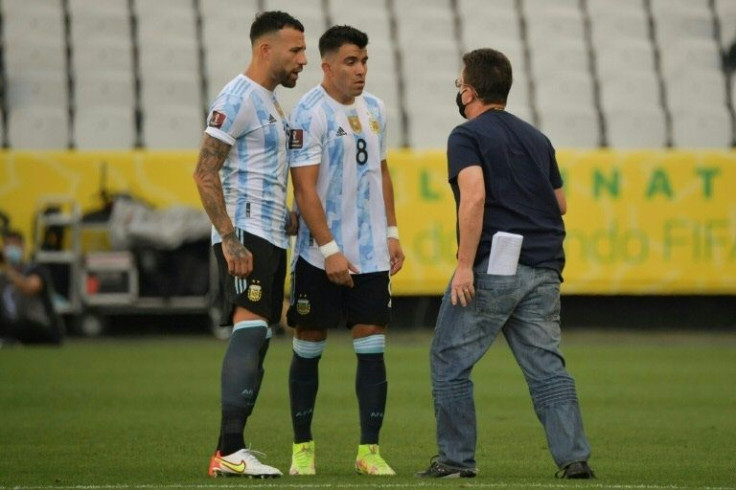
194 11 307 478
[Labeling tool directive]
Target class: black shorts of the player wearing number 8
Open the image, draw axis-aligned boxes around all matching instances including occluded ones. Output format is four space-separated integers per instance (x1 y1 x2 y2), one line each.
286 257 391 329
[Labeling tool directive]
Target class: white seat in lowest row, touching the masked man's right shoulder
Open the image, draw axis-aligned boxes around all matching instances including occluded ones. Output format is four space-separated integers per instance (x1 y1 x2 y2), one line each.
539 105 600 149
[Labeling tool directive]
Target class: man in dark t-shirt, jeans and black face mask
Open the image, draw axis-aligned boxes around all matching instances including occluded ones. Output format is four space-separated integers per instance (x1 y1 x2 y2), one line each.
416 49 594 478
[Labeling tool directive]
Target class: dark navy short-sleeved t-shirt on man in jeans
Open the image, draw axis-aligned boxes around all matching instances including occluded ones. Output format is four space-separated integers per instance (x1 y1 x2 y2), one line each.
447 110 565 275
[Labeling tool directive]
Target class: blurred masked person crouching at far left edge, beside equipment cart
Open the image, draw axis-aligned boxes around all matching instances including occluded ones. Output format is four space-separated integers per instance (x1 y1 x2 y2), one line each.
0 230 65 345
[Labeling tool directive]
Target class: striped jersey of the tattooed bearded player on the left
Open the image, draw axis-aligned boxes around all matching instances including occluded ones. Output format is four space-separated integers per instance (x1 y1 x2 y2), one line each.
205 74 289 249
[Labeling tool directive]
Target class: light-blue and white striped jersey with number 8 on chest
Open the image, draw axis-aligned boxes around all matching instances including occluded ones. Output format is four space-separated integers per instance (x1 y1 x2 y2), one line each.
289 86 390 273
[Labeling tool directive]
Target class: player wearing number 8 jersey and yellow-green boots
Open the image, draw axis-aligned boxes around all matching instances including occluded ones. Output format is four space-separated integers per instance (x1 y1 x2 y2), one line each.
288 26 404 475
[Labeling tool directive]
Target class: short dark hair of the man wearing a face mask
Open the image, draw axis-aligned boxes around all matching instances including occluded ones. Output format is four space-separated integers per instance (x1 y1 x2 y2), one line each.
463 48 513 104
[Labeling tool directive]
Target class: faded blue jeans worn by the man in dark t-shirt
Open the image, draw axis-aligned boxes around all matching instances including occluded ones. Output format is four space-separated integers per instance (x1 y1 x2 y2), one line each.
430 263 590 468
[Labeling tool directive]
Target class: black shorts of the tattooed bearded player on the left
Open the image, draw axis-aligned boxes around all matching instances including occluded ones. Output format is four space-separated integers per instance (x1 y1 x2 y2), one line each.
214 228 286 325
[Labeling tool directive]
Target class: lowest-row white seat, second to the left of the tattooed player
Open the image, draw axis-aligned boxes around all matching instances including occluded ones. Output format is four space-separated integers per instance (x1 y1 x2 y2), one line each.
74 105 135 150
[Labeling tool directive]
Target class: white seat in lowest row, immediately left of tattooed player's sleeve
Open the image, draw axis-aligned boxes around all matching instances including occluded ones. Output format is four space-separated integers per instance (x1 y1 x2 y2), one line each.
143 106 205 150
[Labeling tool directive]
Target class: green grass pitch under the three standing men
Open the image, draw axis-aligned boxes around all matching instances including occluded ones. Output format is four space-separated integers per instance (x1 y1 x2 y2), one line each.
0 330 736 488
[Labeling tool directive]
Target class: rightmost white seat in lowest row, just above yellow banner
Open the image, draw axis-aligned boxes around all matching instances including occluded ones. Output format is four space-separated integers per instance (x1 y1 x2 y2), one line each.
671 106 734 149
